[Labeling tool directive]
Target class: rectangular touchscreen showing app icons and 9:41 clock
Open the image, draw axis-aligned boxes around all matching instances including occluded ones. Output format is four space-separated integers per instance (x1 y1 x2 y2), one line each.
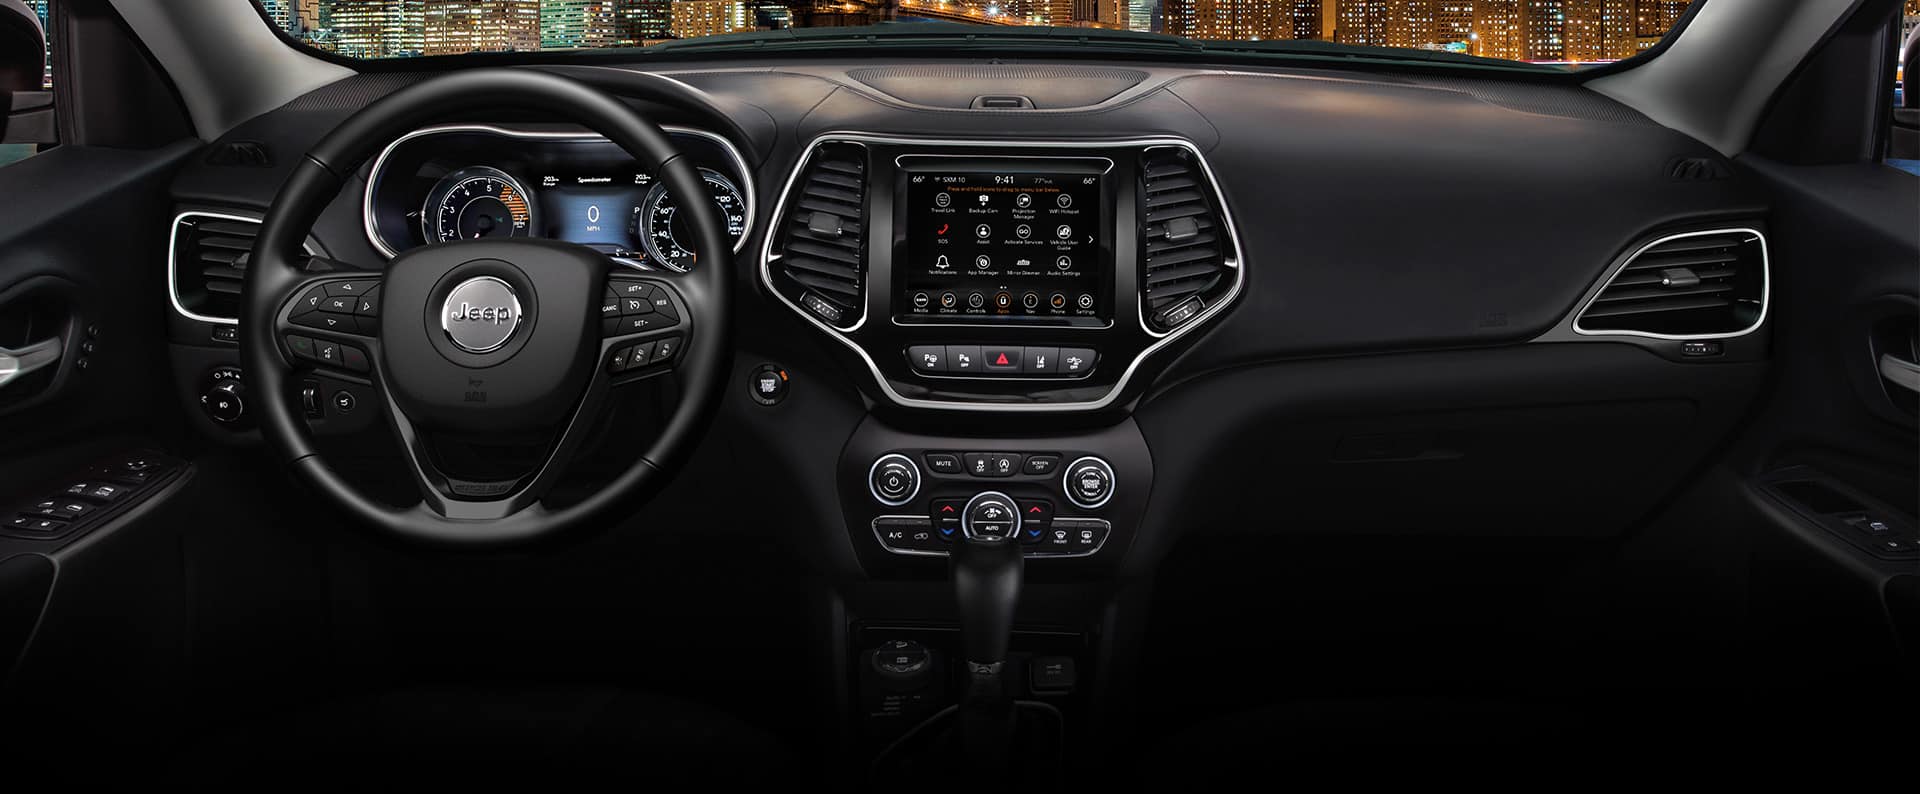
895 171 1112 322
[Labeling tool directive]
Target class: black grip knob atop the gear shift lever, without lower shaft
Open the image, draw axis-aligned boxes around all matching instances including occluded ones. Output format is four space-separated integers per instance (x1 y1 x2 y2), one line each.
952 491 1025 666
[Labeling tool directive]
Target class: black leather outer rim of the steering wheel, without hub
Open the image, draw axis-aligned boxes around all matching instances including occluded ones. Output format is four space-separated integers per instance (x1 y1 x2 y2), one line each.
240 69 733 549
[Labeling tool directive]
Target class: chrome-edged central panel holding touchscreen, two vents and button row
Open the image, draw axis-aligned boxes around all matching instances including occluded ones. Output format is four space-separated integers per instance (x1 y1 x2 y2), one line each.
760 132 1244 412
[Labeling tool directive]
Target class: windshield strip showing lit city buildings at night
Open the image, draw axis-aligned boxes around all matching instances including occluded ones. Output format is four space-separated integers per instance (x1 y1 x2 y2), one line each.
255 0 1695 67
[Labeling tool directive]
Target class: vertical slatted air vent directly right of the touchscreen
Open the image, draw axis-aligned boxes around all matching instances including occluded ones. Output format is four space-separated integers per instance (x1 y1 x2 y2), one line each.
1140 146 1233 332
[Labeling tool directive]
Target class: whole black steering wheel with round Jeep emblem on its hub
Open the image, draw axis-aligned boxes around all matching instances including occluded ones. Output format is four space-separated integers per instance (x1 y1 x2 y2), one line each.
240 69 733 547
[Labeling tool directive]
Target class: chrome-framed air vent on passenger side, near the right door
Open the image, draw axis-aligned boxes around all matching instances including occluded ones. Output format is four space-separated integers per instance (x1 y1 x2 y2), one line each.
1574 228 1766 338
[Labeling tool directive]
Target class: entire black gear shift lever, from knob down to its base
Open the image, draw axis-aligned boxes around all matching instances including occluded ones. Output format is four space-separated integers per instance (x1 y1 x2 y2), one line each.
952 491 1023 777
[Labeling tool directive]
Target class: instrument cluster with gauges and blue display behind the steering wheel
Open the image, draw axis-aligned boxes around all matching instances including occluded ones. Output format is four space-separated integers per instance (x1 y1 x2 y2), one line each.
365 125 756 270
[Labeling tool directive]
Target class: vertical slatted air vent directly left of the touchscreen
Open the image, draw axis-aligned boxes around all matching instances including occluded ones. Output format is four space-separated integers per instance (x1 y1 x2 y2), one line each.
772 144 866 328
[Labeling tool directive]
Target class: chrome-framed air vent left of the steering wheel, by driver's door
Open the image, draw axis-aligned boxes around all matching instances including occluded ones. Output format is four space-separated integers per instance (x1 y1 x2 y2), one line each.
169 213 259 322
